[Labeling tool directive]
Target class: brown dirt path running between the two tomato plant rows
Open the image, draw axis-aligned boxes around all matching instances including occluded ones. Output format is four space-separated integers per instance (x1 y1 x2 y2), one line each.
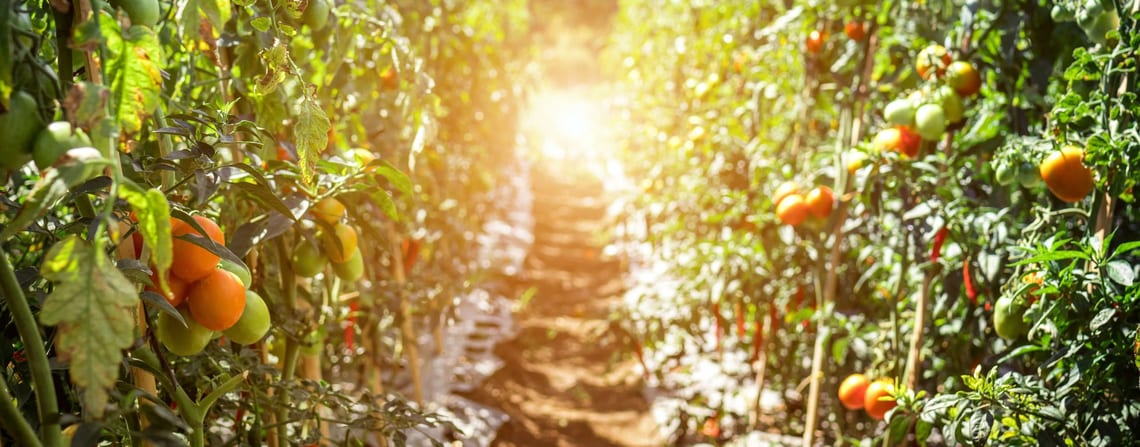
460 168 661 447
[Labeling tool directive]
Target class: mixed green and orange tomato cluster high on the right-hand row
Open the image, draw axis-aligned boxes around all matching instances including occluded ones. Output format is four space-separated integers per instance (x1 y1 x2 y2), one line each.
873 44 982 159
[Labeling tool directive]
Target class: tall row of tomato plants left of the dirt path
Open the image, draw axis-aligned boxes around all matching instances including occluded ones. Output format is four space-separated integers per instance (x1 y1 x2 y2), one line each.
0 0 534 446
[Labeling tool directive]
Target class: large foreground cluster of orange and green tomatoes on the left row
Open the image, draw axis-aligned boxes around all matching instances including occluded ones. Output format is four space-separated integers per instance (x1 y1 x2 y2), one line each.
147 216 270 356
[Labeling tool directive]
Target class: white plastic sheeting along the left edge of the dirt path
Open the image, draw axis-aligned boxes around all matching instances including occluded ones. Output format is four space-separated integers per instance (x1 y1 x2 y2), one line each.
401 160 535 447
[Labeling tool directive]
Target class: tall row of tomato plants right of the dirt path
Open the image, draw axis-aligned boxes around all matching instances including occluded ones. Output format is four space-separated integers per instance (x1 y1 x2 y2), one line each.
604 0 1140 446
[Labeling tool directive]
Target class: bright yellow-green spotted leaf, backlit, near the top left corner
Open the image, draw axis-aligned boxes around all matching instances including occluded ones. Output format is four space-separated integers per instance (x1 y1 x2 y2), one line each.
99 14 165 133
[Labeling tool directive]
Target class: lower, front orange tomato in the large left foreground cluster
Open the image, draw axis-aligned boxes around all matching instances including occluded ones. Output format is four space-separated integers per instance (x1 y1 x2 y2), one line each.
186 268 245 331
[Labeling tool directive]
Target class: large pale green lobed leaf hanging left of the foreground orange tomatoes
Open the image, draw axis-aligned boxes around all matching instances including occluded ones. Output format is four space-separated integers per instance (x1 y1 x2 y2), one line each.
40 236 138 418
